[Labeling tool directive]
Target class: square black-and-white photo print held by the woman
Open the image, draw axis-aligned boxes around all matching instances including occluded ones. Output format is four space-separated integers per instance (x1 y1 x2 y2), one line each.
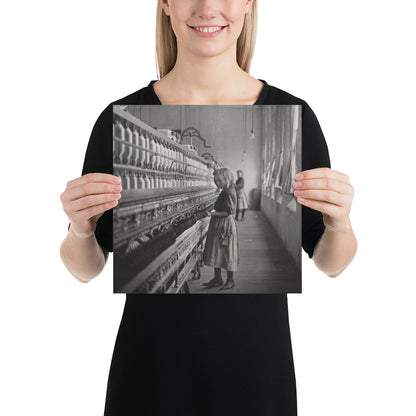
113 105 302 295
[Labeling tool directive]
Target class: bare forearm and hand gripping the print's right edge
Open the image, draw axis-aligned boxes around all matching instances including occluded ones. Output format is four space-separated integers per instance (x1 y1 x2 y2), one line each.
293 168 357 277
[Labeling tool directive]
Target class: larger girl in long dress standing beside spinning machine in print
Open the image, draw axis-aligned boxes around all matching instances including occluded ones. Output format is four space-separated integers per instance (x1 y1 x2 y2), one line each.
202 168 239 289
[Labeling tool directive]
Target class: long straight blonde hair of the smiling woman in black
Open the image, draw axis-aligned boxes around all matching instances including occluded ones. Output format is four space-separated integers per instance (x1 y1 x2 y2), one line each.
156 0 257 79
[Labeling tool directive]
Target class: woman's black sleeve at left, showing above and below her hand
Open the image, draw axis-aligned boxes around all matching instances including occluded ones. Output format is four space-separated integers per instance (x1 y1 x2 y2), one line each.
74 104 113 251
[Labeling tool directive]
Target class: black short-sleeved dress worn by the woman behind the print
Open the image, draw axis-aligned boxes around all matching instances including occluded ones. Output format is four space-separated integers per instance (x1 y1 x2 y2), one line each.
79 80 330 416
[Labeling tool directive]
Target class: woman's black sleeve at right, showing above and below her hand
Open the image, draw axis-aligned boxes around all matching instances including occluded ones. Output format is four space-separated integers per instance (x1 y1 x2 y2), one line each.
302 103 331 258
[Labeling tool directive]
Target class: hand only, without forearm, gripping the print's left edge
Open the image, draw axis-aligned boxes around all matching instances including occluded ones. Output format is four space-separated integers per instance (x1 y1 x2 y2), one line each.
61 173 121 238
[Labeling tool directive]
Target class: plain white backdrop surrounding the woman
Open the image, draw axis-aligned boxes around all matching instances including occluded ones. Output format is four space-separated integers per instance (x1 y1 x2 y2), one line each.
0 0 416 416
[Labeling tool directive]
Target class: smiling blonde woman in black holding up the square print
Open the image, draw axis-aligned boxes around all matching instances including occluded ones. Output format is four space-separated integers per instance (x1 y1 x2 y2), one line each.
61 0 357 416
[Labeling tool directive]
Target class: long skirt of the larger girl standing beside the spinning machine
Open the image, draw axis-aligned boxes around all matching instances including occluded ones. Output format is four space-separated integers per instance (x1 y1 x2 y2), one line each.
202 215 240 272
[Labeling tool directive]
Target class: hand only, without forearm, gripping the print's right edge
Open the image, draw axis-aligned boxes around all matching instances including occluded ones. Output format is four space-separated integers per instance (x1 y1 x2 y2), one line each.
293 168 355 231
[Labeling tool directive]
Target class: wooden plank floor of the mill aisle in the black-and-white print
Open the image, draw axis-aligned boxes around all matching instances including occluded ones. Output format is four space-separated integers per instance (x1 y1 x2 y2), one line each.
188 211 301 294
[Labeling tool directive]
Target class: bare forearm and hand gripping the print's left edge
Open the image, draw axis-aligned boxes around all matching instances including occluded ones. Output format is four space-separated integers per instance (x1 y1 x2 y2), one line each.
60 173 121 283
